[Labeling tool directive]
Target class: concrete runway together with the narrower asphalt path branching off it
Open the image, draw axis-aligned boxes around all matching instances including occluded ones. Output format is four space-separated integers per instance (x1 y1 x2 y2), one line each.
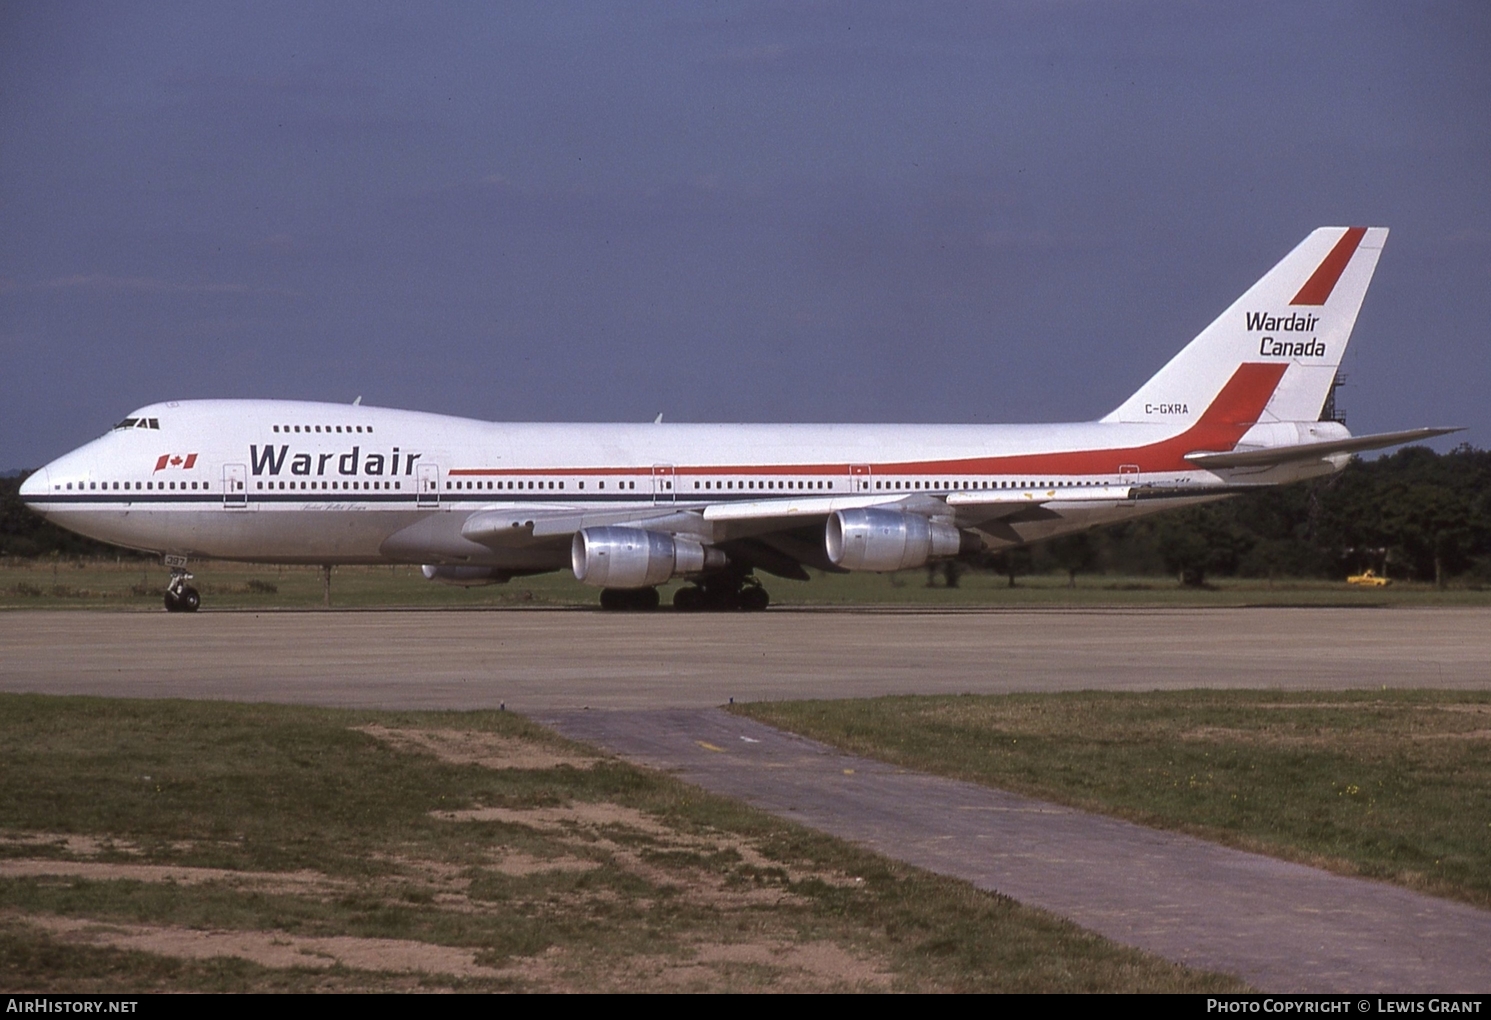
0 608 1491 992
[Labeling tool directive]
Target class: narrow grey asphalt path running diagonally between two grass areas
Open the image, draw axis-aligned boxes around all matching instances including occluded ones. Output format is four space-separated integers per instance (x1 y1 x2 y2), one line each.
538 708 1491 993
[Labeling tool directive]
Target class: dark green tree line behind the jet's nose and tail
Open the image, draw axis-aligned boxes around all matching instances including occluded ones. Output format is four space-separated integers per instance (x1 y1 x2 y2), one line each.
0 444 1491 585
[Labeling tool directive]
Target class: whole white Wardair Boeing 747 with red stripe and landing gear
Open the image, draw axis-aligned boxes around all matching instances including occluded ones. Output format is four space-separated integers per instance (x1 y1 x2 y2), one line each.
21 227 1455 610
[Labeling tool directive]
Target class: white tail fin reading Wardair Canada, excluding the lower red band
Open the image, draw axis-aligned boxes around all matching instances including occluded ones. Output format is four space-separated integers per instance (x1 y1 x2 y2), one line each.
1103 227 1388 425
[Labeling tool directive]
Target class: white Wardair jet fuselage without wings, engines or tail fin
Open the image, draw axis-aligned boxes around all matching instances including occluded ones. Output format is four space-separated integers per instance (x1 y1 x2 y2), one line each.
11 400 1318 570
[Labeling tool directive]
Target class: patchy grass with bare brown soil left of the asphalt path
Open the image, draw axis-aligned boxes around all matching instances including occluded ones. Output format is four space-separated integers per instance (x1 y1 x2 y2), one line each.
0 695 1238 992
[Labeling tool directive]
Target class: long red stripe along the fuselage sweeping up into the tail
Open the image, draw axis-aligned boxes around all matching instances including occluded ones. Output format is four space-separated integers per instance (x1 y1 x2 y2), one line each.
450 362 1288 479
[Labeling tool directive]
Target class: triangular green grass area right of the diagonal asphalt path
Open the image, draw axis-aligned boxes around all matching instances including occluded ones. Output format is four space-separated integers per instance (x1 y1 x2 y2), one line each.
734 689 1491 907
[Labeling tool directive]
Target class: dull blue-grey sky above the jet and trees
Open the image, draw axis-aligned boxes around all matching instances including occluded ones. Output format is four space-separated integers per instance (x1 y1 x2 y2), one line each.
0 1 1491 467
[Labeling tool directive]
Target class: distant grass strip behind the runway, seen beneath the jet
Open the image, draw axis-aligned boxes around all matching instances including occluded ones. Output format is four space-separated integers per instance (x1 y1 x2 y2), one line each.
0 559 1491 610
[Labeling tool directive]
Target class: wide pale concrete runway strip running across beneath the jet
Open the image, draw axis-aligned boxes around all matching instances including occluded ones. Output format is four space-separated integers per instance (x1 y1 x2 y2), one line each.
0 608 1491 711
